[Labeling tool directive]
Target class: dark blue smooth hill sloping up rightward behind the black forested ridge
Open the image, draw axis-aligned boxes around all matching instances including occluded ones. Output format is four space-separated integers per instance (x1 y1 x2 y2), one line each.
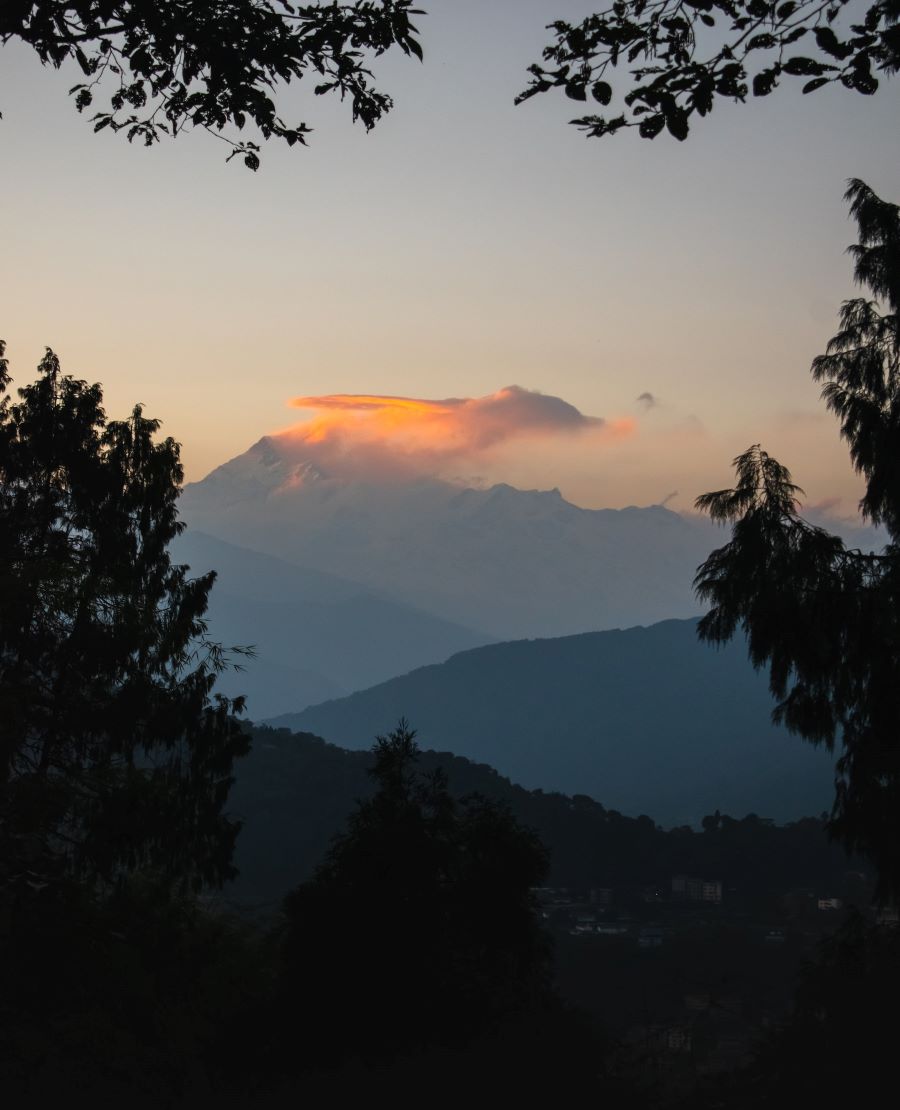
269 620 833 825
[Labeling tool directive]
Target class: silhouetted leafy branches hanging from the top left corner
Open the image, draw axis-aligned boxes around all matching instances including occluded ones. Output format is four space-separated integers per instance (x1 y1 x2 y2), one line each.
0 0 422 170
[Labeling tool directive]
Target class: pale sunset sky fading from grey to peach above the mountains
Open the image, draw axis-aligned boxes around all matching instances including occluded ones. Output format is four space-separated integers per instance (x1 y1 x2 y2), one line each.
0 0 900 514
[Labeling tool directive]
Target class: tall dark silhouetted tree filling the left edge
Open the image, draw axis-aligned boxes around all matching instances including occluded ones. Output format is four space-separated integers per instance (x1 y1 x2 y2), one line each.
0 344 255 1106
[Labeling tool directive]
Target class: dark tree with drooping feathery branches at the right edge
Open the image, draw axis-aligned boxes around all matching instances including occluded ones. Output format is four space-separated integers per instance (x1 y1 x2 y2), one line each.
695 181 900 899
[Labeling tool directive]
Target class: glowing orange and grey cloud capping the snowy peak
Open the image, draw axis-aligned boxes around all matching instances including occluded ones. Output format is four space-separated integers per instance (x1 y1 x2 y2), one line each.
280 385 634 480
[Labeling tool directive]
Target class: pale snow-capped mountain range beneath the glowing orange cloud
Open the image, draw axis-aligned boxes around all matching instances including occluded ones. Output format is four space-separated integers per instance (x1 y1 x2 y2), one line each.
182 436 725 643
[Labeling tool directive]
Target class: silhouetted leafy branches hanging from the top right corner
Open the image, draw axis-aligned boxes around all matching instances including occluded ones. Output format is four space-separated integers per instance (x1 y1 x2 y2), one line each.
517 0 900 139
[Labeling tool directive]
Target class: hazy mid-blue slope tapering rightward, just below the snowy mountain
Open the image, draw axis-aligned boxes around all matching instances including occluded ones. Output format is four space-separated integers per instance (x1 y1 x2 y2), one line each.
173 529 487 718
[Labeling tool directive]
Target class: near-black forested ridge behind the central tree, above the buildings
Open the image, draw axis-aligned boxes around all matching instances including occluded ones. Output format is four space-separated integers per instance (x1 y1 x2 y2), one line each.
225 727 848 909
